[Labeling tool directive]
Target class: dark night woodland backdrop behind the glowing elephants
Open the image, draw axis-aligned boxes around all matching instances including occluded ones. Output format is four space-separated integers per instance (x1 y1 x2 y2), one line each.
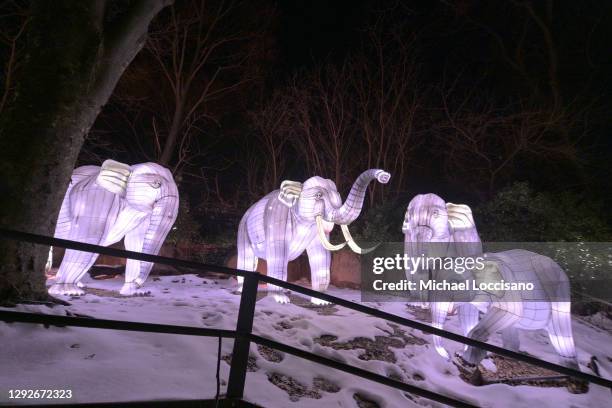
0 0 612 243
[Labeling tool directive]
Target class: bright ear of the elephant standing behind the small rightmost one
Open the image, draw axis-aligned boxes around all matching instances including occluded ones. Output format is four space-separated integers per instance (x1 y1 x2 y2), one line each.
446 203 482 256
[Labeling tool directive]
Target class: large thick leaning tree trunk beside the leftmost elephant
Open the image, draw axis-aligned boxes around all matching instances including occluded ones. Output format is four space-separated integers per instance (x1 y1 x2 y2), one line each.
0 0 171 304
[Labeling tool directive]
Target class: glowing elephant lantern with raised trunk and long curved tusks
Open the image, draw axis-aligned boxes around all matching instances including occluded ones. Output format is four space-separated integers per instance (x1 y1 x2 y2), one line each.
237 169 391 304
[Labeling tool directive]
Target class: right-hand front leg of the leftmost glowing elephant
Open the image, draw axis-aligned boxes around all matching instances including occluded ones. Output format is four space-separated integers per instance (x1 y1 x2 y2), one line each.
119 220 153 296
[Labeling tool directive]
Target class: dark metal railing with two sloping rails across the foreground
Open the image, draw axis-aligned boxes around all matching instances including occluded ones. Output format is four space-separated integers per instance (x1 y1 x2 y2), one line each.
0 229 612 407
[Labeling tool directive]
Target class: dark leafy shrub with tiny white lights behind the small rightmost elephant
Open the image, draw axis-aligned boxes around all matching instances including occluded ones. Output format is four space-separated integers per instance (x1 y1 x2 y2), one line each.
474 183 612 313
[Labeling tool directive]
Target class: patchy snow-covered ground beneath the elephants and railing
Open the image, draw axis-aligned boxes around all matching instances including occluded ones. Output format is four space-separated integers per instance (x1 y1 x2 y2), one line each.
0 275 612 408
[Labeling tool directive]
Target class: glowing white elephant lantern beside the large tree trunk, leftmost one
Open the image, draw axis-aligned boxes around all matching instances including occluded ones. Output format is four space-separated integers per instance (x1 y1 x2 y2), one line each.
49 160 179 296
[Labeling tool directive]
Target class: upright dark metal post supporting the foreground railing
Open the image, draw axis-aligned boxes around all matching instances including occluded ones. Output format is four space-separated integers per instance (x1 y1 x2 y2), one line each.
227 272 259 400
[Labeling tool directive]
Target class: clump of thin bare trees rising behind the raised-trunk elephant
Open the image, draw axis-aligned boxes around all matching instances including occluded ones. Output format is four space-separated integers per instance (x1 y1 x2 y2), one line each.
260 23 422 204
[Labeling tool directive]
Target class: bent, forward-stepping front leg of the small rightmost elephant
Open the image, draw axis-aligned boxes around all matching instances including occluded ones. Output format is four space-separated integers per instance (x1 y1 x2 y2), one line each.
463 302 523 364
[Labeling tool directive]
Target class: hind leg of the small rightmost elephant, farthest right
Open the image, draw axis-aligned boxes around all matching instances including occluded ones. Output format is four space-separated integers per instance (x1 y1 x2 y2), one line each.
546 302 580 370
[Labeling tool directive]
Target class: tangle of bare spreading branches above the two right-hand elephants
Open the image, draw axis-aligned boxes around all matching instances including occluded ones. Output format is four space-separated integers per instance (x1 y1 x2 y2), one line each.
432 87 577 197
